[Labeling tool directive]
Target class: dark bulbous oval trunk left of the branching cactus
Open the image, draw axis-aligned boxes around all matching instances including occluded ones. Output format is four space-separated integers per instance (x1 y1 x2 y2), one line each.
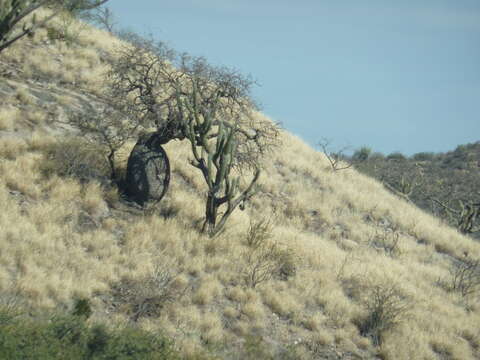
125 133 170 205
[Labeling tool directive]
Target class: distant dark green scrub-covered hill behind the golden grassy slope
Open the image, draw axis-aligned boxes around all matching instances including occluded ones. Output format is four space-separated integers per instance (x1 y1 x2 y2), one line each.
350 142 480 239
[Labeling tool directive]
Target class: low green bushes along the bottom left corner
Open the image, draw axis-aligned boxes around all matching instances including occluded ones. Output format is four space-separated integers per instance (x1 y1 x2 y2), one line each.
0 309 180 360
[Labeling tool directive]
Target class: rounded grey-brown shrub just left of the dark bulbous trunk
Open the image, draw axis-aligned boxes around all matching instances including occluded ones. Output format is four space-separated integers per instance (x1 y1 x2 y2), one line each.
41 137 109 182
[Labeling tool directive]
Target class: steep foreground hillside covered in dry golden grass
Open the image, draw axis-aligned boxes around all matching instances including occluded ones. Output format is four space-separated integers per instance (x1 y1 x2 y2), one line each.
0 11 480 359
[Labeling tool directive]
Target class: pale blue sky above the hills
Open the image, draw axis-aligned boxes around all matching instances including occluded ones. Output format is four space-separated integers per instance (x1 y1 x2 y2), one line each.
108 0 480 154
